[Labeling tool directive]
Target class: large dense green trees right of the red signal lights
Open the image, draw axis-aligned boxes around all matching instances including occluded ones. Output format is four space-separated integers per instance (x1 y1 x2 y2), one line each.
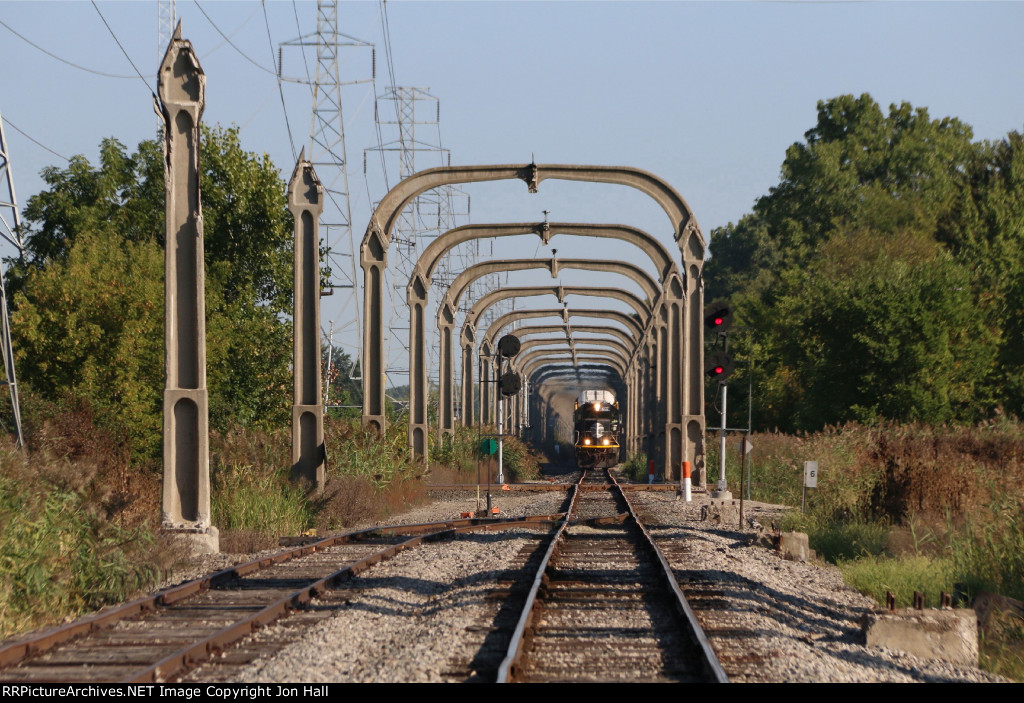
706 94 1011 430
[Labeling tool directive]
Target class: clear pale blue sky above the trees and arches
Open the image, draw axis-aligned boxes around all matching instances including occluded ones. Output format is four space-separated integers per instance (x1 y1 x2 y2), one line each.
0 0 1024 383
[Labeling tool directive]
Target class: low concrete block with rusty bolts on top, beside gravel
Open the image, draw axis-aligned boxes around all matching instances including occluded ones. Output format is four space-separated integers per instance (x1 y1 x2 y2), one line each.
862 608 978 666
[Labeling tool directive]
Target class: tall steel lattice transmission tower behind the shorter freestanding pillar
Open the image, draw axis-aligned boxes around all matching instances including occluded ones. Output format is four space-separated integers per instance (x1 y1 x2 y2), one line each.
278 0 376 397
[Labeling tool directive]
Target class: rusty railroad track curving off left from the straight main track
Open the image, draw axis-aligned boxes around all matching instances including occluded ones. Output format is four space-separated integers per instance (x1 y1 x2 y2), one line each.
0 516 558 683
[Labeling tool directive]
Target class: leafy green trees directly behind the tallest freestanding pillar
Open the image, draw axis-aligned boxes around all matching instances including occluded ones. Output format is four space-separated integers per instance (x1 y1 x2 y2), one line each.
8 126 292 454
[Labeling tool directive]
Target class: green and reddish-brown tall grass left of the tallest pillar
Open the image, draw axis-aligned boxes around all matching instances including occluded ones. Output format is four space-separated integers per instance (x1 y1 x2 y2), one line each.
0 407 167 638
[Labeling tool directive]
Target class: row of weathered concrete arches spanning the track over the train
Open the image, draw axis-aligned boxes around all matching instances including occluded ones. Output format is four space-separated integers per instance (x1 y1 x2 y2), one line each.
360 164 706 483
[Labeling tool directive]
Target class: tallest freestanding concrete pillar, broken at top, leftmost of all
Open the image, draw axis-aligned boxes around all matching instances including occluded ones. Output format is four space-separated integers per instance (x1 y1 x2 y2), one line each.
157 23 220 553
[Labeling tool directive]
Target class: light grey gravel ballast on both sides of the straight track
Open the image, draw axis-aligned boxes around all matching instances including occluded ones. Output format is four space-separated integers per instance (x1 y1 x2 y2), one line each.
189 482 1004 683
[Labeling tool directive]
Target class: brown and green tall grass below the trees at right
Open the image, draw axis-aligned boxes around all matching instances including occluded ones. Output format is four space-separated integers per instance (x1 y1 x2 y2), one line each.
741 420 1024 679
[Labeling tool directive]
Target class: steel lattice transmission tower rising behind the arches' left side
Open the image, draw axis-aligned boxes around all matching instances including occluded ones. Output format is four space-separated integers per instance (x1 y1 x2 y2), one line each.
364 86 468 407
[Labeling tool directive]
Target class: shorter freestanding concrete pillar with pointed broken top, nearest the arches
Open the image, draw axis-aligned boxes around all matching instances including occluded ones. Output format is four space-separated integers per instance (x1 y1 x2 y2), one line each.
288 149 327 492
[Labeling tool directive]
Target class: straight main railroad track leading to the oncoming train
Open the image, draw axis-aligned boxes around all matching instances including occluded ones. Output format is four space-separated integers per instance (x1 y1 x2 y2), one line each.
498 471 727 683
